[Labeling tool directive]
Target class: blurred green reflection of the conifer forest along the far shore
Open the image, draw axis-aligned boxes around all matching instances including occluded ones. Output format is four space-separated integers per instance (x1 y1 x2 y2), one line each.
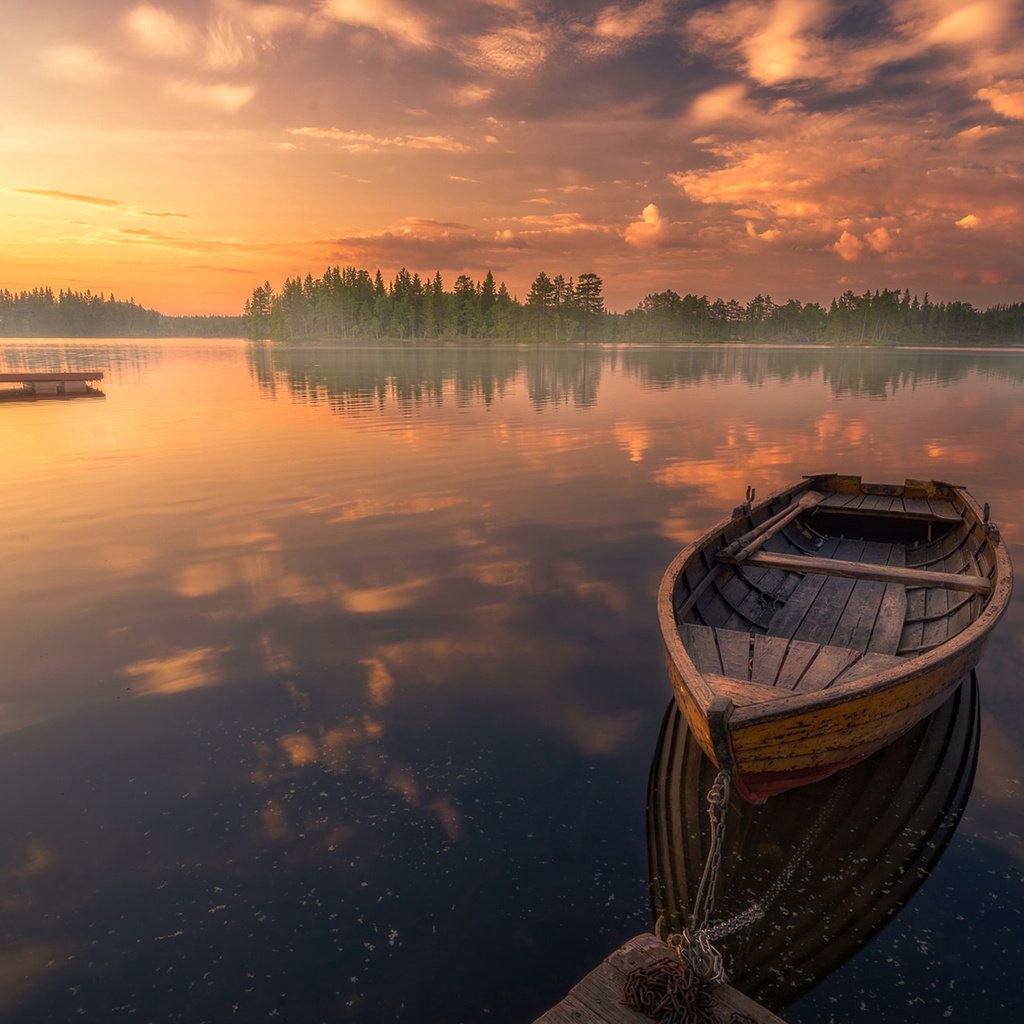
248 343 1024 415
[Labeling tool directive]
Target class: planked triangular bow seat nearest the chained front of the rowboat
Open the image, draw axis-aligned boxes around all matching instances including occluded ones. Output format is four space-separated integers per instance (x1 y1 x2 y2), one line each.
679 623 904 697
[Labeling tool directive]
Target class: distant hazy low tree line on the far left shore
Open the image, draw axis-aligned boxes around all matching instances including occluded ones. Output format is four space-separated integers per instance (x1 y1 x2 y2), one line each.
0 288 246 338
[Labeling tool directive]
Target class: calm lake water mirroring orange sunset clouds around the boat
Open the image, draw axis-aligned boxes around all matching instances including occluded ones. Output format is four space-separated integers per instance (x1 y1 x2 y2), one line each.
0 341 1024 1024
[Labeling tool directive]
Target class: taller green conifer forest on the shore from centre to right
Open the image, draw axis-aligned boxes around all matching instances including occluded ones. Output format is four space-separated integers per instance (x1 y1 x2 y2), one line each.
245 266 1024 344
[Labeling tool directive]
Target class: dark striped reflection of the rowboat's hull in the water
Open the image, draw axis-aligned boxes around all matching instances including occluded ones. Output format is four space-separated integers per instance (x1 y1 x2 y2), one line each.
647 673 980 1010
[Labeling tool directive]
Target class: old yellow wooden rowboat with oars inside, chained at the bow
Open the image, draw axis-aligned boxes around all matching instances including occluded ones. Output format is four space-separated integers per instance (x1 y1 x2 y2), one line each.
657 474 1013 803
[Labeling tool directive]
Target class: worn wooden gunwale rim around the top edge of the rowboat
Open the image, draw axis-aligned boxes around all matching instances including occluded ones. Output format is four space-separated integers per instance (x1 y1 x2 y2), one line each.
657 474 1013 732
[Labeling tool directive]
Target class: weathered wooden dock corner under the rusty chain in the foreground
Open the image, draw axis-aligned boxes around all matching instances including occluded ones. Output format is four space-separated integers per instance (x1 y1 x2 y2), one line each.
534 932 785 1024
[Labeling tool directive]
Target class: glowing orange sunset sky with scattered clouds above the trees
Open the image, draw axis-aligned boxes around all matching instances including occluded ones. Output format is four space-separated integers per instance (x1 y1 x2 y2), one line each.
0 0 1024 313
